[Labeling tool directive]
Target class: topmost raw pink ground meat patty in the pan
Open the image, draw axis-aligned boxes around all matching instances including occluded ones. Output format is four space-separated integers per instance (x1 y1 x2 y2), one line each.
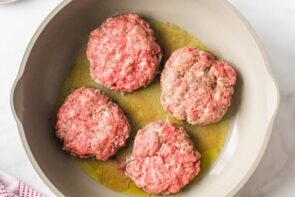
87 13 162 92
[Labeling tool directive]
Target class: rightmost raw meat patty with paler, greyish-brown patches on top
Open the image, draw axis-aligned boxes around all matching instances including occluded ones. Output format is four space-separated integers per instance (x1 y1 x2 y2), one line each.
161 47 236 125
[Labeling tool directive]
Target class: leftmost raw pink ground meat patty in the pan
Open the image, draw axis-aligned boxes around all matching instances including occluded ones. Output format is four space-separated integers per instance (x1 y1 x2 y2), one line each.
56 87 130 160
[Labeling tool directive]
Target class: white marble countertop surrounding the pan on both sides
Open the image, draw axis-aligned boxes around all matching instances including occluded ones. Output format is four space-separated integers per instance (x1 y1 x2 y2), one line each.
0 0 295 197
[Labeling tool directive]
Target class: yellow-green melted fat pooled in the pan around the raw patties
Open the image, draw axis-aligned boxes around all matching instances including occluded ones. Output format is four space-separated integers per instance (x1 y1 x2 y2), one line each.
60 20 229 196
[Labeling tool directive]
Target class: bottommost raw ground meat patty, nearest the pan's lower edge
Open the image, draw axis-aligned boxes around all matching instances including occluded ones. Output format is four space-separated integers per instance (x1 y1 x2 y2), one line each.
126 122 201 194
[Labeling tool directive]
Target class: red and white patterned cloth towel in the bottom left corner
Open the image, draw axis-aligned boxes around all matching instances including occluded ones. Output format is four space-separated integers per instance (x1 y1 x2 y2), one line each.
0 169 45 197
